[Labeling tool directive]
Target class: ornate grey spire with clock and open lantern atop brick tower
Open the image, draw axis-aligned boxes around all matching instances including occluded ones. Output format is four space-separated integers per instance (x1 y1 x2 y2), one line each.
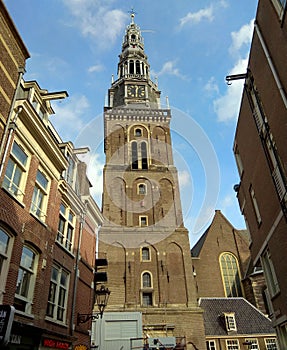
108 10 160 108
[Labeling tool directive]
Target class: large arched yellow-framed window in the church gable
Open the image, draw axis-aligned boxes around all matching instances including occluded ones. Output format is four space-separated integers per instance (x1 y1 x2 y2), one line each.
220 253 242 297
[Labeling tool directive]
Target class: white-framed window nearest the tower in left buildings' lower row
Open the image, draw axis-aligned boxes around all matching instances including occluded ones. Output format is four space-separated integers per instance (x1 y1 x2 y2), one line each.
46 265 69 322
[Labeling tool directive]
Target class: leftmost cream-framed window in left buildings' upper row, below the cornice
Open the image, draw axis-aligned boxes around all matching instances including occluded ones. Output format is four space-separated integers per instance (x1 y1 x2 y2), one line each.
2 142 28 200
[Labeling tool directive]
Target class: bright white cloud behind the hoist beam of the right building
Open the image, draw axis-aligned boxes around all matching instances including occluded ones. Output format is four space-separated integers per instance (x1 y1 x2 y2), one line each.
213 58 248 122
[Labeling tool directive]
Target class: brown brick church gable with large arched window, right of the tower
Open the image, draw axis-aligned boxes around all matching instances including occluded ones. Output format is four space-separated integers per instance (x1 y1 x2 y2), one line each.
191 210 267 314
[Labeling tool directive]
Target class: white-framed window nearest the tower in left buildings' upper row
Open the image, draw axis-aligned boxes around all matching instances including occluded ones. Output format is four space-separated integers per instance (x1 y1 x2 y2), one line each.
57 203 75 251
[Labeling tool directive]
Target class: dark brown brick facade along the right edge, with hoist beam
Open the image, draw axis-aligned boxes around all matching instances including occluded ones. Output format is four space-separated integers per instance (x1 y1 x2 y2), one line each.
235 0 287 349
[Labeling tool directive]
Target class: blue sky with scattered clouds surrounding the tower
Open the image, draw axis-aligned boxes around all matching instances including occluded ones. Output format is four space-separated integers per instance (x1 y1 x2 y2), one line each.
4 0 257 245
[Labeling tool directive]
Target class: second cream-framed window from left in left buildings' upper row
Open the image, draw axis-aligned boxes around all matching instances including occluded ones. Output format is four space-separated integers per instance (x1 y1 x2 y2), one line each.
30 170 49 221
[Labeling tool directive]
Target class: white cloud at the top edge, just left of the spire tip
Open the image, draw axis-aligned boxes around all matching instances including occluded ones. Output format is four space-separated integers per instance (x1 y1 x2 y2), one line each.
63 0 128 47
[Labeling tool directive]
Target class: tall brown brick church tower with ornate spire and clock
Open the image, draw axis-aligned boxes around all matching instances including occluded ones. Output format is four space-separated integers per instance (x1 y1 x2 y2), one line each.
98 14 205 349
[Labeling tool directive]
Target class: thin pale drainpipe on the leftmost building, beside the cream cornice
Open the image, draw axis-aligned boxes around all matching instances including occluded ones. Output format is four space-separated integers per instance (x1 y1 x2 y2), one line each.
0 67 25 178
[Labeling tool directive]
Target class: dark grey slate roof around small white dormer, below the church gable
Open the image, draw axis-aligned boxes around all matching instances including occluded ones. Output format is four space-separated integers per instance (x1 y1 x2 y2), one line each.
199 298 275 336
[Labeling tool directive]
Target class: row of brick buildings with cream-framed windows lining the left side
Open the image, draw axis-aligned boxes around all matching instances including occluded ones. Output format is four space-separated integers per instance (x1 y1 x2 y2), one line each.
0 1 102 350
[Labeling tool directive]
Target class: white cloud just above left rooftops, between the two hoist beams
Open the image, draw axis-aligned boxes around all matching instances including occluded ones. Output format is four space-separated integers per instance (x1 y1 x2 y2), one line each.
51 95 90 141
